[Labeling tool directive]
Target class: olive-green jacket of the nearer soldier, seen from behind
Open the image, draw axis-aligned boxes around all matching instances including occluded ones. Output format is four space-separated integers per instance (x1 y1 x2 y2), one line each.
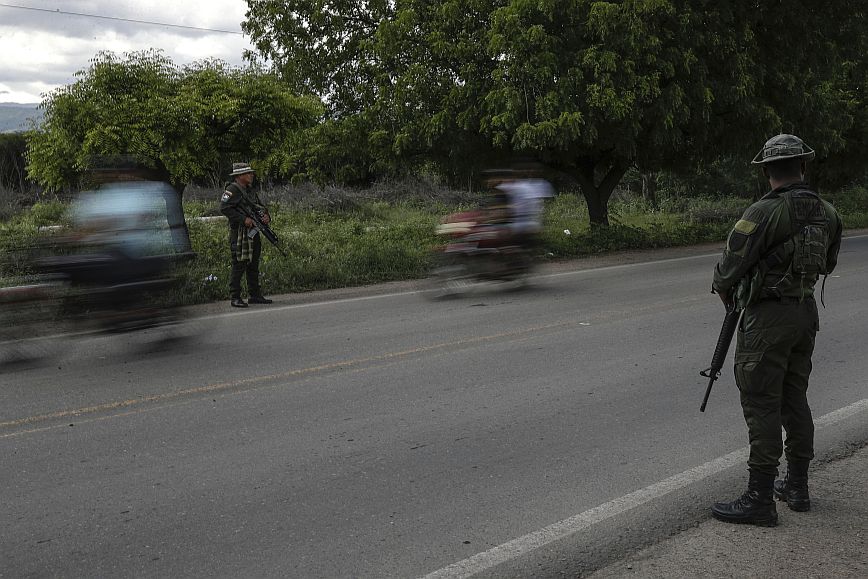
711 183 843 308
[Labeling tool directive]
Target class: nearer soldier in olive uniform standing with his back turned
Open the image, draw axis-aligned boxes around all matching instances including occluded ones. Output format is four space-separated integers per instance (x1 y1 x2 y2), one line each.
712 135 842 526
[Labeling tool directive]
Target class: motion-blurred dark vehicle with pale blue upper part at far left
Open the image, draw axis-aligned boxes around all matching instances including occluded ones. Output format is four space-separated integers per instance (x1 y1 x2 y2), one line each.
0 172 193 363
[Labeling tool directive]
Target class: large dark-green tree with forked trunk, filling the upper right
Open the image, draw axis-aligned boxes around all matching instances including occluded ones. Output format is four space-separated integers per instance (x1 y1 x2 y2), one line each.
245 0 864 223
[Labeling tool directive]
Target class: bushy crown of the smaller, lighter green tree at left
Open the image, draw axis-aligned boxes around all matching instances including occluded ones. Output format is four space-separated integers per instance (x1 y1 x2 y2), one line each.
28 51 322 192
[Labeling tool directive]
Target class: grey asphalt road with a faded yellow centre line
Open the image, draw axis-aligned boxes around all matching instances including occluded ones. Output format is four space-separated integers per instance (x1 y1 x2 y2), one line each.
0 236 868 577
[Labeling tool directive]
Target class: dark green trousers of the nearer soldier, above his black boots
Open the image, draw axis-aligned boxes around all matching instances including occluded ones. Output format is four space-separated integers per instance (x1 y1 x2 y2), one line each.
735 299 819 475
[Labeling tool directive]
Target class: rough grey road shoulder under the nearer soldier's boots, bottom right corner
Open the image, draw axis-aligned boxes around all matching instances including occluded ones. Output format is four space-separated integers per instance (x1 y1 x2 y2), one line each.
589 445 868 579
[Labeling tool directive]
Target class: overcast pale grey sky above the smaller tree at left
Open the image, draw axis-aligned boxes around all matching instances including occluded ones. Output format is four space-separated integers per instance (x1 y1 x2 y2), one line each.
0 0 251 103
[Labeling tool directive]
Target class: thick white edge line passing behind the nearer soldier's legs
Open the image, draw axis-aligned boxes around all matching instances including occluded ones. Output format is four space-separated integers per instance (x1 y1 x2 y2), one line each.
423 398 868 579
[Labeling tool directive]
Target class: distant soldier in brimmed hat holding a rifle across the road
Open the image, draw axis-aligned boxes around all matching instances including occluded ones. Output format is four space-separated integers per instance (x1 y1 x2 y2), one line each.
220 163 272 308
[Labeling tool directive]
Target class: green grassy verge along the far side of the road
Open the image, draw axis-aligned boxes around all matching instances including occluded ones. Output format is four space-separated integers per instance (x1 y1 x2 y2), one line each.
0 188 868 303
